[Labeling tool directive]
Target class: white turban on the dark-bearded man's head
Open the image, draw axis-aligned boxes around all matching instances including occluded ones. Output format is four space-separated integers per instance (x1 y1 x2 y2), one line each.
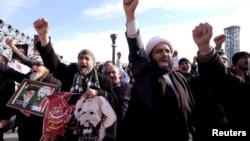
146 36 173 57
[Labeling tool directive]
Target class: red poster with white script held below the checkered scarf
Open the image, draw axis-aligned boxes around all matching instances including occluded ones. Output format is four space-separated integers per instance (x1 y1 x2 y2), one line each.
42 92 75 141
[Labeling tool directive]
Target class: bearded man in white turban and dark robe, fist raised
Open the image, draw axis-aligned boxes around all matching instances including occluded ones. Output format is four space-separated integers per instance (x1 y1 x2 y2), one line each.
123 0 193 141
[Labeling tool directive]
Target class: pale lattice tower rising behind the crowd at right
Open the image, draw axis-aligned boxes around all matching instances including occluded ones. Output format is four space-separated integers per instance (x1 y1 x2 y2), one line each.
224 26 240 66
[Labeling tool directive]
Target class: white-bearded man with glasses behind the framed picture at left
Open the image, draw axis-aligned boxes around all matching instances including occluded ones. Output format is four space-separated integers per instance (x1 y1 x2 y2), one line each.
0 52 61 141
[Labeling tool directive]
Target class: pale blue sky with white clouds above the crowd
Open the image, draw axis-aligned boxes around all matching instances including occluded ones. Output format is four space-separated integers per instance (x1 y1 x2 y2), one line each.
0 0 250 62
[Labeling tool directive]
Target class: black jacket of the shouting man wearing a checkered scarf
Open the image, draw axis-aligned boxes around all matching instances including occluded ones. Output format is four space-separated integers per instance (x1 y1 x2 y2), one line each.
36 42 118 141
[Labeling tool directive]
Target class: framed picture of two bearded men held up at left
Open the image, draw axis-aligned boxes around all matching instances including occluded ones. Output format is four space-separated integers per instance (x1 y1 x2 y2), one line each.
7 79 58 116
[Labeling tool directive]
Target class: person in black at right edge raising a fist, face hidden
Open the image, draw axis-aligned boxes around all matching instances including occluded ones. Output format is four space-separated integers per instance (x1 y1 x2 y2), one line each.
193 23 250 141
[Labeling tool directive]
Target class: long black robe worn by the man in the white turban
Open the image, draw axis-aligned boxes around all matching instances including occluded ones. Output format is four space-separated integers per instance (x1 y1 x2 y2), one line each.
124 33 194 141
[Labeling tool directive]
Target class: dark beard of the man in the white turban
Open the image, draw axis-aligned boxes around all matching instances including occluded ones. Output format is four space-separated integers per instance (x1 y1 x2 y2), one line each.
151 60 173 75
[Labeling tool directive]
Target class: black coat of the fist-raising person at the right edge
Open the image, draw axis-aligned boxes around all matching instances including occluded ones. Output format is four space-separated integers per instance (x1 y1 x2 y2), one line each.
198 50 250 132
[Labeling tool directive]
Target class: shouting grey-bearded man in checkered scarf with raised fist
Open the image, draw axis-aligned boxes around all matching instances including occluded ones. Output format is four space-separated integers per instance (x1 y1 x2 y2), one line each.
34 18 117 141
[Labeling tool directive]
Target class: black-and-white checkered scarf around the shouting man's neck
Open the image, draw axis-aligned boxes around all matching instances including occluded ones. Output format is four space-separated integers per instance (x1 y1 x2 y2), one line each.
70 69 100 93
